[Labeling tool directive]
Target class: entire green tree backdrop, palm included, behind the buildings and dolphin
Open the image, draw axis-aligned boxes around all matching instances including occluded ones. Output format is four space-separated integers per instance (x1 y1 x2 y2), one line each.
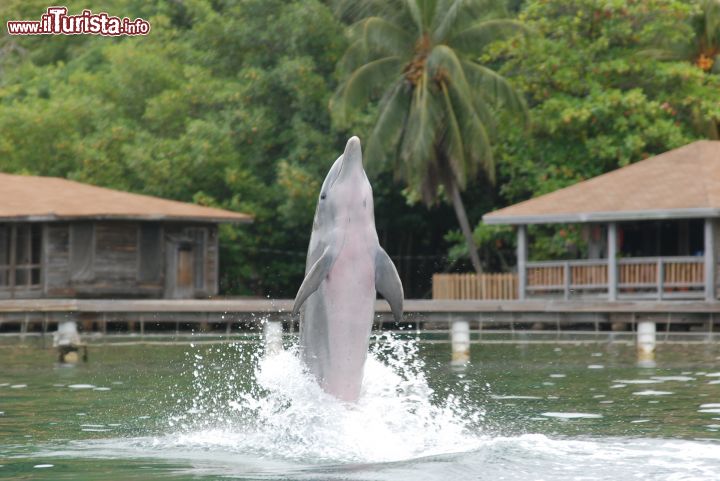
0 0 720 297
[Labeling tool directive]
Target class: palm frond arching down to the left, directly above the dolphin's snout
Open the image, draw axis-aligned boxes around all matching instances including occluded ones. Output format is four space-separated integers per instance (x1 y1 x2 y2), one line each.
330 56 402 125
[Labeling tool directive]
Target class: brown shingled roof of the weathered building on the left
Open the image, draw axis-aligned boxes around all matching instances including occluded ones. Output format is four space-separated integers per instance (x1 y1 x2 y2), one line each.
0 173 252 222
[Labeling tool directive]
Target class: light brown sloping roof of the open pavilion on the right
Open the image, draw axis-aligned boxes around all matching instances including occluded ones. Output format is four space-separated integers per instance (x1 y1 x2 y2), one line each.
483 140 720 224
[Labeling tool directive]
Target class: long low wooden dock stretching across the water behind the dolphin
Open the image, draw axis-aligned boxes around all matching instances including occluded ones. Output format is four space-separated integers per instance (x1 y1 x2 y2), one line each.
0 299 720 334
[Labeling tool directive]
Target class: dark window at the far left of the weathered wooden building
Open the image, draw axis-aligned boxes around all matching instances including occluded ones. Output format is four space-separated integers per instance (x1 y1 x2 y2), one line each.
0 224 42 291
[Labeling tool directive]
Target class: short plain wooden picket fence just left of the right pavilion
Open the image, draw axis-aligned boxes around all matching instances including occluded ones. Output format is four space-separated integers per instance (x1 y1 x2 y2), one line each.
433 273 518 300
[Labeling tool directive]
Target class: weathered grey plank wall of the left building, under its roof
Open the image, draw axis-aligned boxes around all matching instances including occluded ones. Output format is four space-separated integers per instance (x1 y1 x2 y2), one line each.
0 221 218 299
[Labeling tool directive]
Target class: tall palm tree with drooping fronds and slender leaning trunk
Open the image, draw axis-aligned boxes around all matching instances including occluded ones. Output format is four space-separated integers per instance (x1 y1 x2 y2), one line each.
330 0 527 273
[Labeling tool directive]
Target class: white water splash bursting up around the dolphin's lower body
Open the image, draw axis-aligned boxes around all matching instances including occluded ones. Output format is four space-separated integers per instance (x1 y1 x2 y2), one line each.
165 333 484 463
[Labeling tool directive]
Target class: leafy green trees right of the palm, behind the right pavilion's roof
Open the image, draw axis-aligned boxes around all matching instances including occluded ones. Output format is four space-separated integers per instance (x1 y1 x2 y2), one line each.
466 0 720 259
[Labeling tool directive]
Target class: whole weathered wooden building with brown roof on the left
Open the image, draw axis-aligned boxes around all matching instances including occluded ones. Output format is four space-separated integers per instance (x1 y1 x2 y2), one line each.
0 174 252 299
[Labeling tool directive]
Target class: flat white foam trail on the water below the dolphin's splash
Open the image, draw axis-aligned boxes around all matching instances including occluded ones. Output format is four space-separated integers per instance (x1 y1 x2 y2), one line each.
32 432 720 481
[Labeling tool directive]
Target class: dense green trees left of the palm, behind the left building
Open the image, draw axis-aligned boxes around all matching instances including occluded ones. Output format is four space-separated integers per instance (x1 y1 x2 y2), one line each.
0 0 345 296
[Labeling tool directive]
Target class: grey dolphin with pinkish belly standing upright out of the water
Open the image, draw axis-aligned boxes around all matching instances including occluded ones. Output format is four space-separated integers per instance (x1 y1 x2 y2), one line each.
293 137 403 401
